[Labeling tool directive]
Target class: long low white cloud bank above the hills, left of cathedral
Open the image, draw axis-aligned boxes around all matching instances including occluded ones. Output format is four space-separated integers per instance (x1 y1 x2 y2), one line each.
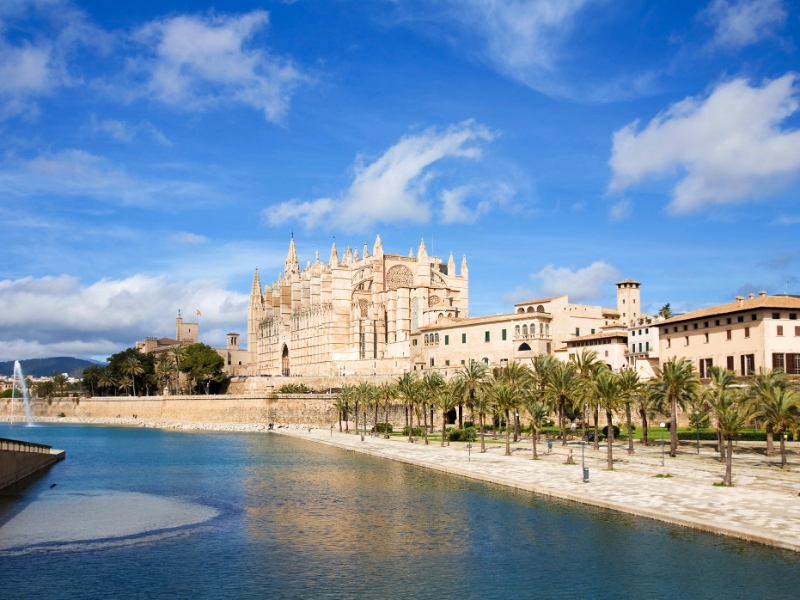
0 275 249 360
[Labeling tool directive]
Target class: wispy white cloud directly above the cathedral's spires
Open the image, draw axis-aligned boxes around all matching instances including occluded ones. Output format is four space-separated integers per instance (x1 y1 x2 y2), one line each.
264 121 494 229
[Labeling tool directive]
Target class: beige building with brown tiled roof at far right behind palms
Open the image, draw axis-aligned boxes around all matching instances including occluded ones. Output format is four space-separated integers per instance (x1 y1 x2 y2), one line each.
658 292 800 378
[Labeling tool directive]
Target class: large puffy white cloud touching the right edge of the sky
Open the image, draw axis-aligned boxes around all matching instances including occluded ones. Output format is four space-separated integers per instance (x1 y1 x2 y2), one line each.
609 74 800 213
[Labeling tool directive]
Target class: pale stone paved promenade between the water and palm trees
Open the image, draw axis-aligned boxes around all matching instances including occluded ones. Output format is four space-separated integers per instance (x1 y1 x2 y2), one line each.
275 429 800 552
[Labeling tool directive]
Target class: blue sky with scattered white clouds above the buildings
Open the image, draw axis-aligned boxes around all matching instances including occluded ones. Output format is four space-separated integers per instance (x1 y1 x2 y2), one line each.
0 0 800 360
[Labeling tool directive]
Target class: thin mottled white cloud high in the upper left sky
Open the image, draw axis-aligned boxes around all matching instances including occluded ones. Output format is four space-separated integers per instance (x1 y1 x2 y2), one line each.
133 10 309 121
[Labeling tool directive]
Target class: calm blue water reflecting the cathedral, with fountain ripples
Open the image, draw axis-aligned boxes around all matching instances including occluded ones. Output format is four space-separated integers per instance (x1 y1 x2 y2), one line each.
0 425 800 599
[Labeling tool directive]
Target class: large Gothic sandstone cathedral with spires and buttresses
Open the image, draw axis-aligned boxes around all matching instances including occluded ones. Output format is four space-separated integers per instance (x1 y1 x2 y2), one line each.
247 236 469 376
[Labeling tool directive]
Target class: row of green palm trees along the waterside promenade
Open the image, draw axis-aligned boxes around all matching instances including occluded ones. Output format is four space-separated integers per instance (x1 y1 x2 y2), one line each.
326 350 800 484
